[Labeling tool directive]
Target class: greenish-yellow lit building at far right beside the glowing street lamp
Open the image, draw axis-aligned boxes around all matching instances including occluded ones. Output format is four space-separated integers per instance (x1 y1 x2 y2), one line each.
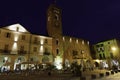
93 39 120 68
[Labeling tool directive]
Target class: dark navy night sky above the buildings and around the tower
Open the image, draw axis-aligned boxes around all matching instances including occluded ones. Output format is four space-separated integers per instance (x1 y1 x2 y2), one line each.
0 0 120 43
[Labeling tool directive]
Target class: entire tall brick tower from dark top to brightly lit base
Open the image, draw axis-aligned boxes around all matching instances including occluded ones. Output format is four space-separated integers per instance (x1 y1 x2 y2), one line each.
47 3 63 69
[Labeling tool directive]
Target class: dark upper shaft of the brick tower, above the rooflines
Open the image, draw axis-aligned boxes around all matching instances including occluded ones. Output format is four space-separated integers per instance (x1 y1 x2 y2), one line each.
47 3 62 37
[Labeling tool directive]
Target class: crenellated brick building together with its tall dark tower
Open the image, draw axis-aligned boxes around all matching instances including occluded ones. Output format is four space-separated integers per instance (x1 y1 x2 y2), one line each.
47 4 92 67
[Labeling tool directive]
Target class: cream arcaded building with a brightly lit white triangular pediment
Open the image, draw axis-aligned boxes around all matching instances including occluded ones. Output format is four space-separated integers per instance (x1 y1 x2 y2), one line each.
0 24 53 70
